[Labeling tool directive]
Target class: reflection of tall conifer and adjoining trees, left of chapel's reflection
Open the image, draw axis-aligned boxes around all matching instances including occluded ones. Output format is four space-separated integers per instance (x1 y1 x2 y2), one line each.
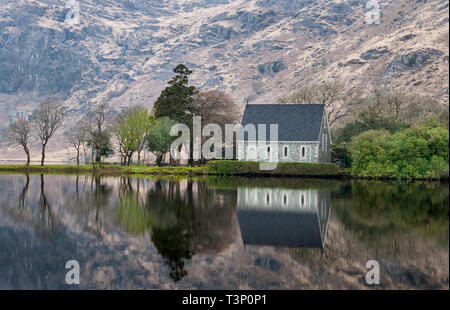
117 180 237 281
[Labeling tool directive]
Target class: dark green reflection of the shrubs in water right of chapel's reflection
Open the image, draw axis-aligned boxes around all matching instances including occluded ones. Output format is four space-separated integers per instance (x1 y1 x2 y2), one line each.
333 181 449 245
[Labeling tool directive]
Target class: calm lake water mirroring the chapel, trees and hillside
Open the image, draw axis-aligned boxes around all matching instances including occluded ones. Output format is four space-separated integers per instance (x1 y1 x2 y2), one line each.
0 174 449 289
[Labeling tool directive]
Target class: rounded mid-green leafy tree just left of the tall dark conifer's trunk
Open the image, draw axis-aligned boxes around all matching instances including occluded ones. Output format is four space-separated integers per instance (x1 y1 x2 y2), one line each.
146 117 177 165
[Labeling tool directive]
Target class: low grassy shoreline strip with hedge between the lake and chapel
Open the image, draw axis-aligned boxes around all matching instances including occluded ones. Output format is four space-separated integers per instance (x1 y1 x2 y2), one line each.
0 164 449 182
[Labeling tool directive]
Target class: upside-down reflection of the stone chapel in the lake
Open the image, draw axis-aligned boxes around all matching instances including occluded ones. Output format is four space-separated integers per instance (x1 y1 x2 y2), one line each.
237 188 330 248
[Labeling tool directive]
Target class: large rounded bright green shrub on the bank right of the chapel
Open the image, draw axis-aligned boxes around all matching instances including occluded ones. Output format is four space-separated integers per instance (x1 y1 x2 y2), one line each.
349 125 449 179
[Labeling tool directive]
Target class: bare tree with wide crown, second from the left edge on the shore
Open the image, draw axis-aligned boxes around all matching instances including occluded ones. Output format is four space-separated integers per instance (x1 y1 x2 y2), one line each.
32 101 64 166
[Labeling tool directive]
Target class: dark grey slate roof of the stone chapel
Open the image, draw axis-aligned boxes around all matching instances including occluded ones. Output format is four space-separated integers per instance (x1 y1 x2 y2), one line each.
238 104 325 141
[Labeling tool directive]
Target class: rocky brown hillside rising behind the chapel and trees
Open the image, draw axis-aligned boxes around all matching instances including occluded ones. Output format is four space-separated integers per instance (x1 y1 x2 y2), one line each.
0 0 449 158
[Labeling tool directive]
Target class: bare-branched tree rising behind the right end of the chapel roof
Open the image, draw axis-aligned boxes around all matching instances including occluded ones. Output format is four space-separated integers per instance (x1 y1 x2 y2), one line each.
278 82 361 126
